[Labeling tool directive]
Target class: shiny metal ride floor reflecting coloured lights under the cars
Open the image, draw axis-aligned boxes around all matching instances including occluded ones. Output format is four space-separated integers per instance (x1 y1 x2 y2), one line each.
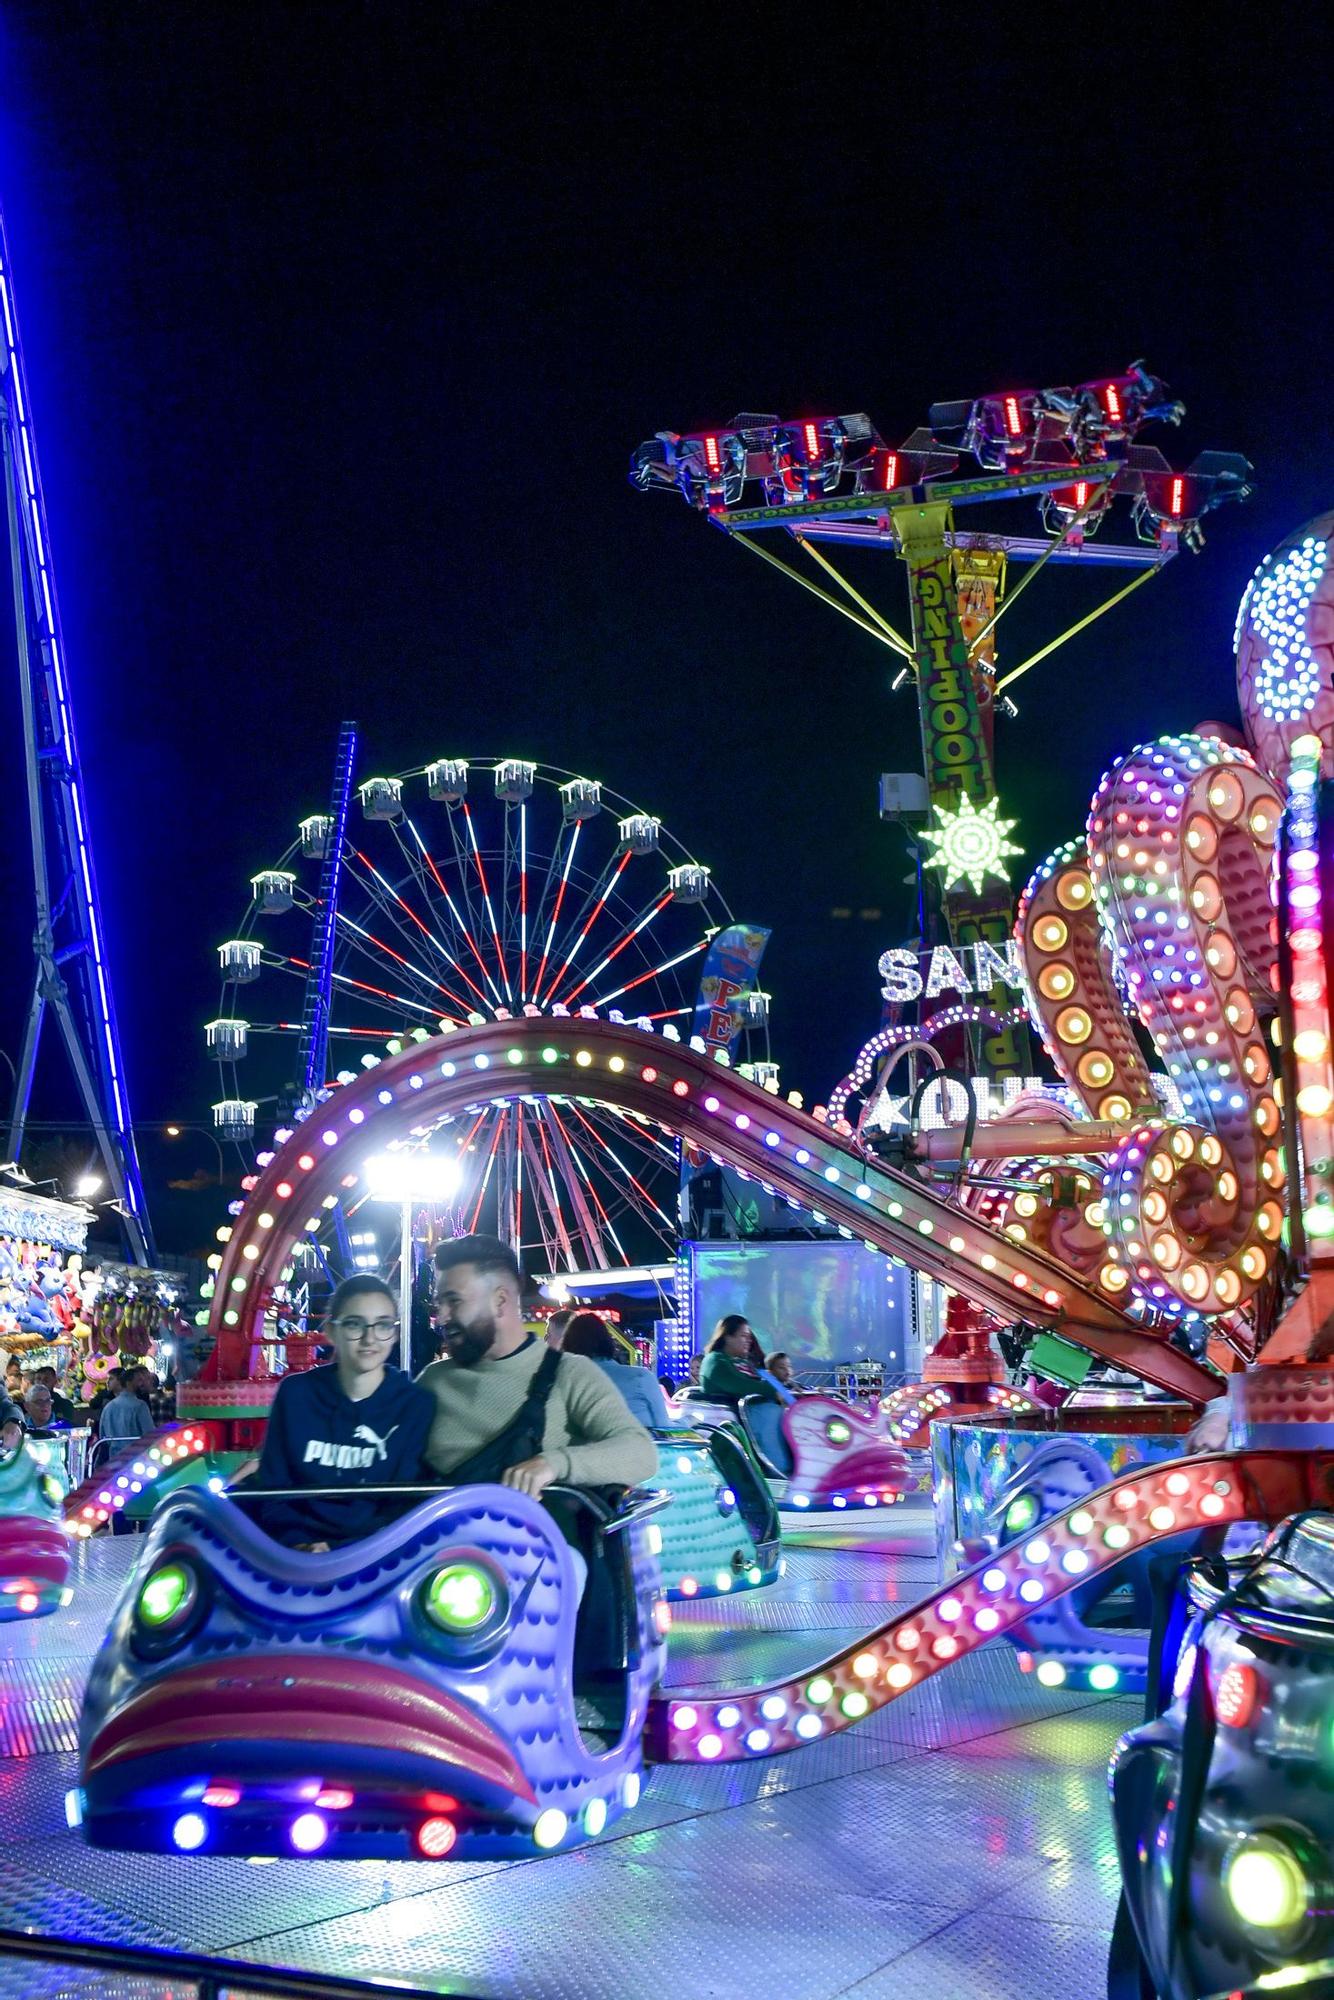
0 1500 1138 2000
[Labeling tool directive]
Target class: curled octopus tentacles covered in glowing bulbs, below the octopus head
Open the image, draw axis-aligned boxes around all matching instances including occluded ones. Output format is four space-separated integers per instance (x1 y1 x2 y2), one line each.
1018 736 1284 1318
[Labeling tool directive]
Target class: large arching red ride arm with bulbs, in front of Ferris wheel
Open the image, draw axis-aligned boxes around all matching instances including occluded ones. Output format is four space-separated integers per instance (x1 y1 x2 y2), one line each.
208 1020 1218 1402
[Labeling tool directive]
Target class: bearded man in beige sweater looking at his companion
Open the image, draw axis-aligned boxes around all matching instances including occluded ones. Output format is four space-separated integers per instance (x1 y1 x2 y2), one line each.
420 1236 658 1500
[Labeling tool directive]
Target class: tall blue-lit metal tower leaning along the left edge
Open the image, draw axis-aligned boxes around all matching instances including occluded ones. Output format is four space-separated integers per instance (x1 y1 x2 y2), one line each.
0 216 154 1264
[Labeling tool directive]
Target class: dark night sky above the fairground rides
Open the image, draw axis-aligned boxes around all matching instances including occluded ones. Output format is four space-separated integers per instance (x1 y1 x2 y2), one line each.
0 0 1330 1228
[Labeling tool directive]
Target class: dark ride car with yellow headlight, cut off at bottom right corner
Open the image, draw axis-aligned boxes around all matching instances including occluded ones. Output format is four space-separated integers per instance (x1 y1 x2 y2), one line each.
1110 1512 1334 2000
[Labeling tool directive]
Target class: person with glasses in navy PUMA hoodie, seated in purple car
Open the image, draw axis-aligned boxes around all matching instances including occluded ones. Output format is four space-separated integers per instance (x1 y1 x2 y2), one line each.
254 1276 434 1554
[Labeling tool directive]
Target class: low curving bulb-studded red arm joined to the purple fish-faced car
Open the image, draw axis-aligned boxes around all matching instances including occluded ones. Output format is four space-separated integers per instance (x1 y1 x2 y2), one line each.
648 1452 1334 1764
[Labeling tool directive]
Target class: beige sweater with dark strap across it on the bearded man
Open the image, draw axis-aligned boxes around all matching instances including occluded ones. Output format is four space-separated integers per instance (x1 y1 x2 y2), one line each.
418 1338 658 1486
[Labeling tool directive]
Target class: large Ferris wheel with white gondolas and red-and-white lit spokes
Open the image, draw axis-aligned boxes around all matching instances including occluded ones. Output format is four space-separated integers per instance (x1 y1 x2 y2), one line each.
206 756 776 1272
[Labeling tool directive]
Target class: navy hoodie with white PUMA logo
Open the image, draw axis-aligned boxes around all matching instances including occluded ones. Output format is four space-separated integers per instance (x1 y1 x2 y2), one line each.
254 1366 436 1542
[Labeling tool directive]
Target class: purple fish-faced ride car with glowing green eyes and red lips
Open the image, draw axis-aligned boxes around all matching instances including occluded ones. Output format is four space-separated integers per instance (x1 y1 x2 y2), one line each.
70 1486 662 1860
